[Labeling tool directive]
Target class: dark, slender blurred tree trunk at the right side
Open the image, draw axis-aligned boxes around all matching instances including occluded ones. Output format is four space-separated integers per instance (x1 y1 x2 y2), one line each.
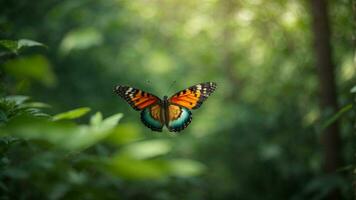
311 0 342 199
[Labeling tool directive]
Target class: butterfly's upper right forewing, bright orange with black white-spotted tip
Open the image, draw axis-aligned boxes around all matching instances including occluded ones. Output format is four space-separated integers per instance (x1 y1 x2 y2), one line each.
168 82 216 109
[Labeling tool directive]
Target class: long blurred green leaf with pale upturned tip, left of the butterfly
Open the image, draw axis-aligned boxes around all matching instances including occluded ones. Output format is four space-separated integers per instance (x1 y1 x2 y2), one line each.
0 114 122 151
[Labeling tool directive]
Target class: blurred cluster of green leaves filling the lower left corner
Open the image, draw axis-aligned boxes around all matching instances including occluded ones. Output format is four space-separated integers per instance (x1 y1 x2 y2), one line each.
0 96 204 199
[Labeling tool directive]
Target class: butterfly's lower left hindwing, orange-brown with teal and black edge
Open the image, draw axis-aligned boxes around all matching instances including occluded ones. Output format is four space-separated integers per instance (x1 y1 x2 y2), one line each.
141 104 164 132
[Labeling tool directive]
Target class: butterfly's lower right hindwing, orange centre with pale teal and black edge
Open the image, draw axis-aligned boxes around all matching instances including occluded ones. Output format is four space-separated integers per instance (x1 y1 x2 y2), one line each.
167 104 192 132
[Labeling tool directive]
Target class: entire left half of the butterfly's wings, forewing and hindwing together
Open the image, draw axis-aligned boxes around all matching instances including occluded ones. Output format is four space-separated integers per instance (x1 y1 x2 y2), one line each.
115 85 164 132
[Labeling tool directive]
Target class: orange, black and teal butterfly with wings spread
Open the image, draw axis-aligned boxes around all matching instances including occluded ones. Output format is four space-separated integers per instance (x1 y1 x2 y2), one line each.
115 82 216 132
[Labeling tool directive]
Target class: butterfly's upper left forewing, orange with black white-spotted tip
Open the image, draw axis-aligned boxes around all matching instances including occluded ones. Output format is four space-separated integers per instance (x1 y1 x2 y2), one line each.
115 85 161 110
